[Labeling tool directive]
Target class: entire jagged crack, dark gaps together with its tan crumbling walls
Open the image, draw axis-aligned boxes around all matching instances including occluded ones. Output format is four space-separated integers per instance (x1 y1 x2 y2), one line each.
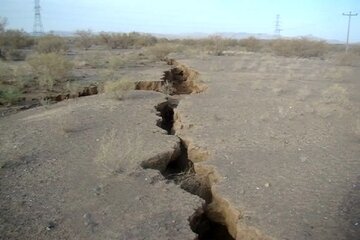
142 61 239 240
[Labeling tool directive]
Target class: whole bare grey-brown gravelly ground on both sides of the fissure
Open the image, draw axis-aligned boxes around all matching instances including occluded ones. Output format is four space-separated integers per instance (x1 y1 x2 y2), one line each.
0 54 360 240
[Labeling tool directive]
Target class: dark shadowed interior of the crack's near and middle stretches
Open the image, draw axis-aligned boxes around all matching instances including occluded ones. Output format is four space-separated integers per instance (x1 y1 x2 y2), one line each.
148 98 234 240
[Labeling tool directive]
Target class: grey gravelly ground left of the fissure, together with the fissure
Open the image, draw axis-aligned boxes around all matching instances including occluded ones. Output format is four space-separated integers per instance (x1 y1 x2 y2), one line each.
0 60 233 239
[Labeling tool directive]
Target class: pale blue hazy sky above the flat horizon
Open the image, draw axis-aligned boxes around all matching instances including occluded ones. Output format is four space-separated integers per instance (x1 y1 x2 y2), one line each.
0 0 360 42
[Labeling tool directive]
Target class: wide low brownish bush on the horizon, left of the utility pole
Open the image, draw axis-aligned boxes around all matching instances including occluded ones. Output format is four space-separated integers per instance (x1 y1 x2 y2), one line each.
271 38 328 58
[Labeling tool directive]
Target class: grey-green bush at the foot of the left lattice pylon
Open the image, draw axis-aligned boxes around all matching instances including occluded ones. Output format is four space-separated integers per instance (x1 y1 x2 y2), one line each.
35 35 68 53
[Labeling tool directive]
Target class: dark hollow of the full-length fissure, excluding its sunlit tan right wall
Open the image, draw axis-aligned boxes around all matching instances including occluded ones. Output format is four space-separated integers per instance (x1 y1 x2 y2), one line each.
141 61 235 240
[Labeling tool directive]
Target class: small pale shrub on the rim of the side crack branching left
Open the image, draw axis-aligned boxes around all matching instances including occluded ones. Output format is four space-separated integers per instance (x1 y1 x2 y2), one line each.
104 78 136 100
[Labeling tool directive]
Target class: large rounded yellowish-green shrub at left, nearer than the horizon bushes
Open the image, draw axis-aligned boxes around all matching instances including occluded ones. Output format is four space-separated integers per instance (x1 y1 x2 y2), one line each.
27 53 73 90
